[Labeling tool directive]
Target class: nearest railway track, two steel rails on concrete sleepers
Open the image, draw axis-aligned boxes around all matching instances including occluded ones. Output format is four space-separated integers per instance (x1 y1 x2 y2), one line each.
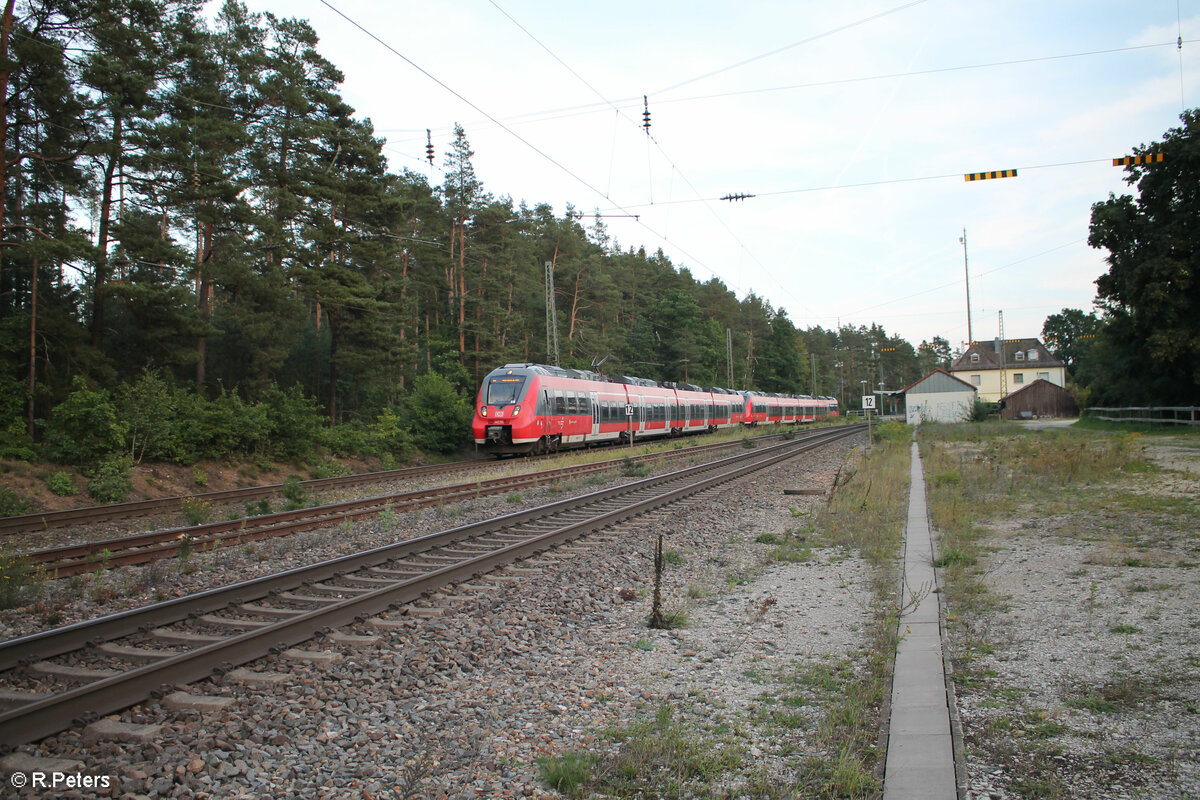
0 426 859 747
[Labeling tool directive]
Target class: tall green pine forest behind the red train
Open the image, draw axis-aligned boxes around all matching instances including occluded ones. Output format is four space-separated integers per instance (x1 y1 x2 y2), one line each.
0 0 950 474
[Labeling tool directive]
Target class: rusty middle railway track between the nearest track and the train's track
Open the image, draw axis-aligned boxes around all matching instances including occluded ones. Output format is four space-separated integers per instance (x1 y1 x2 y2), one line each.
25 437 796 578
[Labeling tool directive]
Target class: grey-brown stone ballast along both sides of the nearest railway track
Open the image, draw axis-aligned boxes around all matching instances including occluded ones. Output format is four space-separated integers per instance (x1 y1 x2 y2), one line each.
2 445 871 798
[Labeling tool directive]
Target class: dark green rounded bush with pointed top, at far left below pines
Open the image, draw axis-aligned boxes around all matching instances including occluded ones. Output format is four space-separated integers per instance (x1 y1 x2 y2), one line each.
46 375 127 464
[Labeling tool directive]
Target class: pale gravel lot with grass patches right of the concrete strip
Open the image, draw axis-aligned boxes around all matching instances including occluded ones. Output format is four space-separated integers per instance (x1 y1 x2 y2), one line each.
950 440 1200 800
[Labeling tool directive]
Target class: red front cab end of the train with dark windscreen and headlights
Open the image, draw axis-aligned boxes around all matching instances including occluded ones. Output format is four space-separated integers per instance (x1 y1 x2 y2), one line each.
470 363 545 456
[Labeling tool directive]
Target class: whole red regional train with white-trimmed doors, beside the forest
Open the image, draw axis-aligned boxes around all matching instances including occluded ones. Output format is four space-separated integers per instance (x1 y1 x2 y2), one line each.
472 363 838 455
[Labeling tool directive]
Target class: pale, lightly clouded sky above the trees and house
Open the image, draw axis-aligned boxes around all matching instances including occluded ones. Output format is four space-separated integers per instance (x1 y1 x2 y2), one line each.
229 0 1200 347
